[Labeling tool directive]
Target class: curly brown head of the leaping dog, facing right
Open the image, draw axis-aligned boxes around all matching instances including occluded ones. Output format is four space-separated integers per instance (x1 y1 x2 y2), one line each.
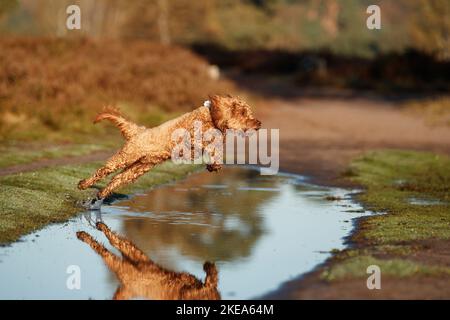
209 96 261 132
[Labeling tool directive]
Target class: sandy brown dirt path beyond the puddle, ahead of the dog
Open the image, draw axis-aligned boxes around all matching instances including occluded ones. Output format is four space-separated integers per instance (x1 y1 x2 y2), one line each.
258 94 450 185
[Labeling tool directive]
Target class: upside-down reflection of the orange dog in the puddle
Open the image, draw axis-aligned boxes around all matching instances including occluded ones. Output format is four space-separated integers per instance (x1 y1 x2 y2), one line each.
77 222 220 300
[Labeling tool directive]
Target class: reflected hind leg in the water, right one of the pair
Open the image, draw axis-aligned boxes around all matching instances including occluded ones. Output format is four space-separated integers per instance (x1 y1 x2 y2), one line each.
96 222 151 263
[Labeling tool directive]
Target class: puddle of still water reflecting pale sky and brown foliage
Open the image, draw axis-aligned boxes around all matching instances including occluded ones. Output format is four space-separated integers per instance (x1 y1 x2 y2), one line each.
0 168 369 299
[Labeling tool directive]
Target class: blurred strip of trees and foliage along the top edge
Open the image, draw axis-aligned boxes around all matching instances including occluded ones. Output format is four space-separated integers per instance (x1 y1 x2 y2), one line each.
0 0 450 60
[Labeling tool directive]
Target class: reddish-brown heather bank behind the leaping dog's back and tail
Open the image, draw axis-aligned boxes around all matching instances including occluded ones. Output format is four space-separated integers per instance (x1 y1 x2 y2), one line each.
0 38 234 142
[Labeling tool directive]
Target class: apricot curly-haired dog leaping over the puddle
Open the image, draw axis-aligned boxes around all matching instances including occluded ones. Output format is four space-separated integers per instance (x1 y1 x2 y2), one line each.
78 96 261 209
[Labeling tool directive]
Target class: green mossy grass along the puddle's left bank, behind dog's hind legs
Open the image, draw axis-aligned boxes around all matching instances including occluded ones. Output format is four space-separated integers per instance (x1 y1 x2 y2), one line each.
0 162 198 244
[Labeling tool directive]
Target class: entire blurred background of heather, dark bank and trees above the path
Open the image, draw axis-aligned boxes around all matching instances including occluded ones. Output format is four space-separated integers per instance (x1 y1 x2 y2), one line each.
0 0 450 143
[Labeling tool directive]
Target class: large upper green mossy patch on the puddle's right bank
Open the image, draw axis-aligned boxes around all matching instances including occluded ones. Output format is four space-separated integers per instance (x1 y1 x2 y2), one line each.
351 151 450 244
